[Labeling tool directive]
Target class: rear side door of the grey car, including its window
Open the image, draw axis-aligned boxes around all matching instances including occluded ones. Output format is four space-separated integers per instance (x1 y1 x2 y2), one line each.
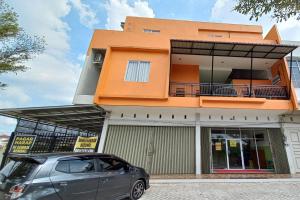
50 157 100 200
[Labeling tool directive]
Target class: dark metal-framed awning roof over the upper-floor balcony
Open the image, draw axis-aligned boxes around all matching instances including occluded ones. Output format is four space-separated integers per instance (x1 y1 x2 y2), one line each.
171 40 298 59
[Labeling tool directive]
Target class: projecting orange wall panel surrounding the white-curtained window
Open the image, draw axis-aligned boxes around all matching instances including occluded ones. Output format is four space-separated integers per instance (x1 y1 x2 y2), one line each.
96 49 169 99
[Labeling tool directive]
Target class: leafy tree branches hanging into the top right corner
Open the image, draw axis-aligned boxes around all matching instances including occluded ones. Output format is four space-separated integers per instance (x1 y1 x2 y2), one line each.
234 0 300 22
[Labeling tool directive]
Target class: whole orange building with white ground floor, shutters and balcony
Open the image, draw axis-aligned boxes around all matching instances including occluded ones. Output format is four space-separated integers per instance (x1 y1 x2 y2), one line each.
2 17 298 174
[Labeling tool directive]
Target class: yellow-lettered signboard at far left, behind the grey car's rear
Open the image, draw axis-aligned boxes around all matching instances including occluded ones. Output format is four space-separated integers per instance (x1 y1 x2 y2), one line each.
9 135 36 154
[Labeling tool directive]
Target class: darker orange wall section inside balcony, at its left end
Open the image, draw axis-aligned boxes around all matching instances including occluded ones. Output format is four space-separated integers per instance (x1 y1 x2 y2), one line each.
170 65 200 83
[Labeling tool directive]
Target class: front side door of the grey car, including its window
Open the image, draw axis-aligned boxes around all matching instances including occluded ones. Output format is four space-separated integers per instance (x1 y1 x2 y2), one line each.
97 157 131 200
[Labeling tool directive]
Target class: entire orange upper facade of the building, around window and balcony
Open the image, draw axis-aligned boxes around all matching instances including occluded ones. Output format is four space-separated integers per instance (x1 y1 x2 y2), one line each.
88 17 295 109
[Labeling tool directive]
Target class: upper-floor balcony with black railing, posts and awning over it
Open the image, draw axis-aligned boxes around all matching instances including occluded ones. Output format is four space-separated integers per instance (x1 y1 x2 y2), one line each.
169 40 296 99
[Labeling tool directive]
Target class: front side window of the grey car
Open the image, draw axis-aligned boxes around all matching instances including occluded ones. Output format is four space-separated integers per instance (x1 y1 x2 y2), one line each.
99 157 128 171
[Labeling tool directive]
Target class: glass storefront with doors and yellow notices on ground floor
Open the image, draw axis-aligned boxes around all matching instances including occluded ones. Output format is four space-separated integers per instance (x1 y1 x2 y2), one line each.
211 128 274 170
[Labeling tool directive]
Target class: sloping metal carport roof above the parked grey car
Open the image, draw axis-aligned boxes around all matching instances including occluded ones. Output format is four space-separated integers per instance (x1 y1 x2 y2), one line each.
0 105 106 132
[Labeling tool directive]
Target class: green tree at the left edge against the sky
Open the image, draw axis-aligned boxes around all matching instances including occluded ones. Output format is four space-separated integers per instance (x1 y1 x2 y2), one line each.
0 0 45 88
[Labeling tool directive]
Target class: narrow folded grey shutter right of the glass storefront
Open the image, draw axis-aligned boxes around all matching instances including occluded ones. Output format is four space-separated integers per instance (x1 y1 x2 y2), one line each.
268 128 290 174
